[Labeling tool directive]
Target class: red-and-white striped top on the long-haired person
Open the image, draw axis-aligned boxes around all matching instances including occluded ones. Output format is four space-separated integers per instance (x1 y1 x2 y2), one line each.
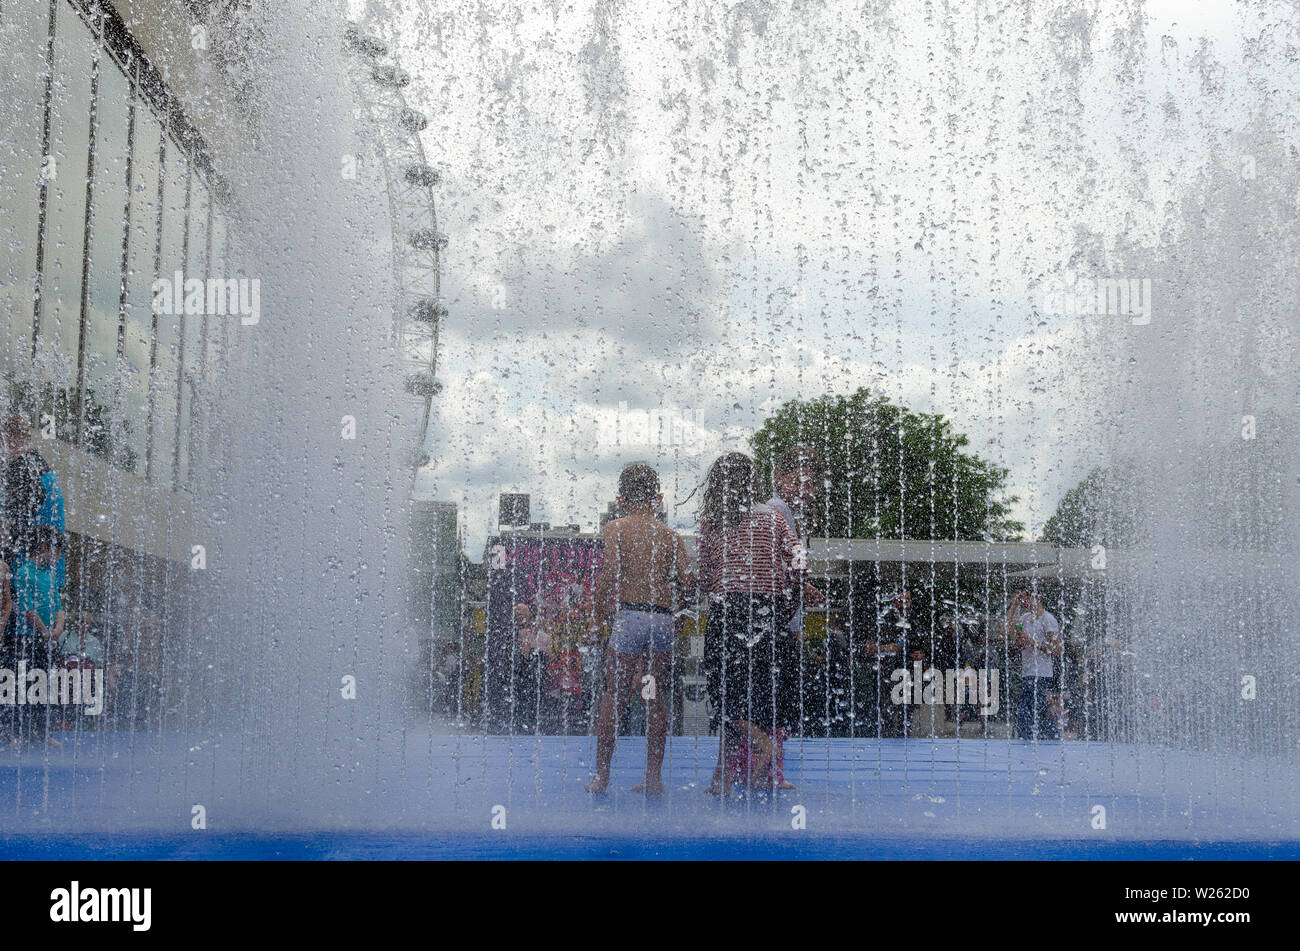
699 505 807 599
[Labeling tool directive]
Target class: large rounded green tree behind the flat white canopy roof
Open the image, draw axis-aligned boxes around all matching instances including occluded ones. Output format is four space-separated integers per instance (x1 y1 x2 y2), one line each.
750 387 1024 540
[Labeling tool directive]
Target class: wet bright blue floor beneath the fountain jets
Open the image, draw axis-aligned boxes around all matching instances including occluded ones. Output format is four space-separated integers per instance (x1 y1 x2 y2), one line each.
0 733 1300 860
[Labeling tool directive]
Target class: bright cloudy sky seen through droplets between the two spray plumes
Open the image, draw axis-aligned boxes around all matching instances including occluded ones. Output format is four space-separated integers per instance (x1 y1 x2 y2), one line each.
374 0 1289 551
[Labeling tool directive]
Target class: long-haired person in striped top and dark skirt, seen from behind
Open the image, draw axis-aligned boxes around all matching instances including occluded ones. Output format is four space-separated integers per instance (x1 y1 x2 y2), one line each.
699 452 807 795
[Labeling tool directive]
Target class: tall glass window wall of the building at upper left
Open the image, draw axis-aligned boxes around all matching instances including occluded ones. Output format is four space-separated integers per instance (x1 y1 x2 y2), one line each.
0 0 234 492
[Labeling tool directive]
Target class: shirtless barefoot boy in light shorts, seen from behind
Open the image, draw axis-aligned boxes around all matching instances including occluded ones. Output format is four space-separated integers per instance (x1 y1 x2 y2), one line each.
586 463 693 795
